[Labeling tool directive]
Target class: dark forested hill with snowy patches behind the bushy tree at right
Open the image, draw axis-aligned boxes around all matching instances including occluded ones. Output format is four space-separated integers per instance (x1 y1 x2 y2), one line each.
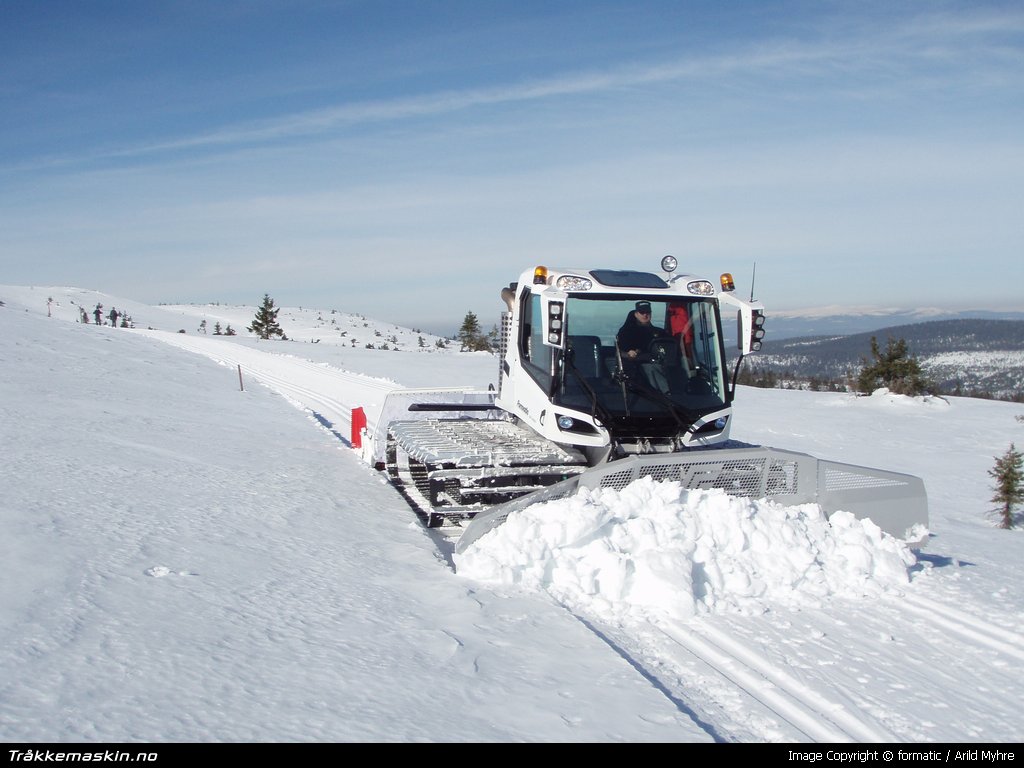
750 318 1024 398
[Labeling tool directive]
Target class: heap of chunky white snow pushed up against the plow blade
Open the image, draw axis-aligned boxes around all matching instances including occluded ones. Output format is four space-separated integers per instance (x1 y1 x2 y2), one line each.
457 478 915 621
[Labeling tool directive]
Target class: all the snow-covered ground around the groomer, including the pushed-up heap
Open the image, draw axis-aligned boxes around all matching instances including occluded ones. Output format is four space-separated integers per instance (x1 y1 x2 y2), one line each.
0 287 1024 742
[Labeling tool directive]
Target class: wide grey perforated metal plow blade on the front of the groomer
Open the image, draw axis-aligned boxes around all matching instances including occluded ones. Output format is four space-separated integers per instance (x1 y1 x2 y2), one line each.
456 447 928 553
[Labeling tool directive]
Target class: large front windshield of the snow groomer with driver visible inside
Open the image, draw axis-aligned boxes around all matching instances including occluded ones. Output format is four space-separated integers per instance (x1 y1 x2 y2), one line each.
554 296 727 417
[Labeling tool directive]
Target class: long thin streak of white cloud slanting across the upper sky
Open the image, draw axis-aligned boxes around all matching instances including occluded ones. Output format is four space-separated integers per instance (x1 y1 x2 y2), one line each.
16 5 1024 173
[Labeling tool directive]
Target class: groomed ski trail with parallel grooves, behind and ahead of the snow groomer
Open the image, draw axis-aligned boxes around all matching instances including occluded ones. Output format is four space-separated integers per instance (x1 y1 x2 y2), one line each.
135 330 1024 744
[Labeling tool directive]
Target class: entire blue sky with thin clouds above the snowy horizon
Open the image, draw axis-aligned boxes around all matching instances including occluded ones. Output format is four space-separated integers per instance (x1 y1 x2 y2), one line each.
0 0 1024 330
